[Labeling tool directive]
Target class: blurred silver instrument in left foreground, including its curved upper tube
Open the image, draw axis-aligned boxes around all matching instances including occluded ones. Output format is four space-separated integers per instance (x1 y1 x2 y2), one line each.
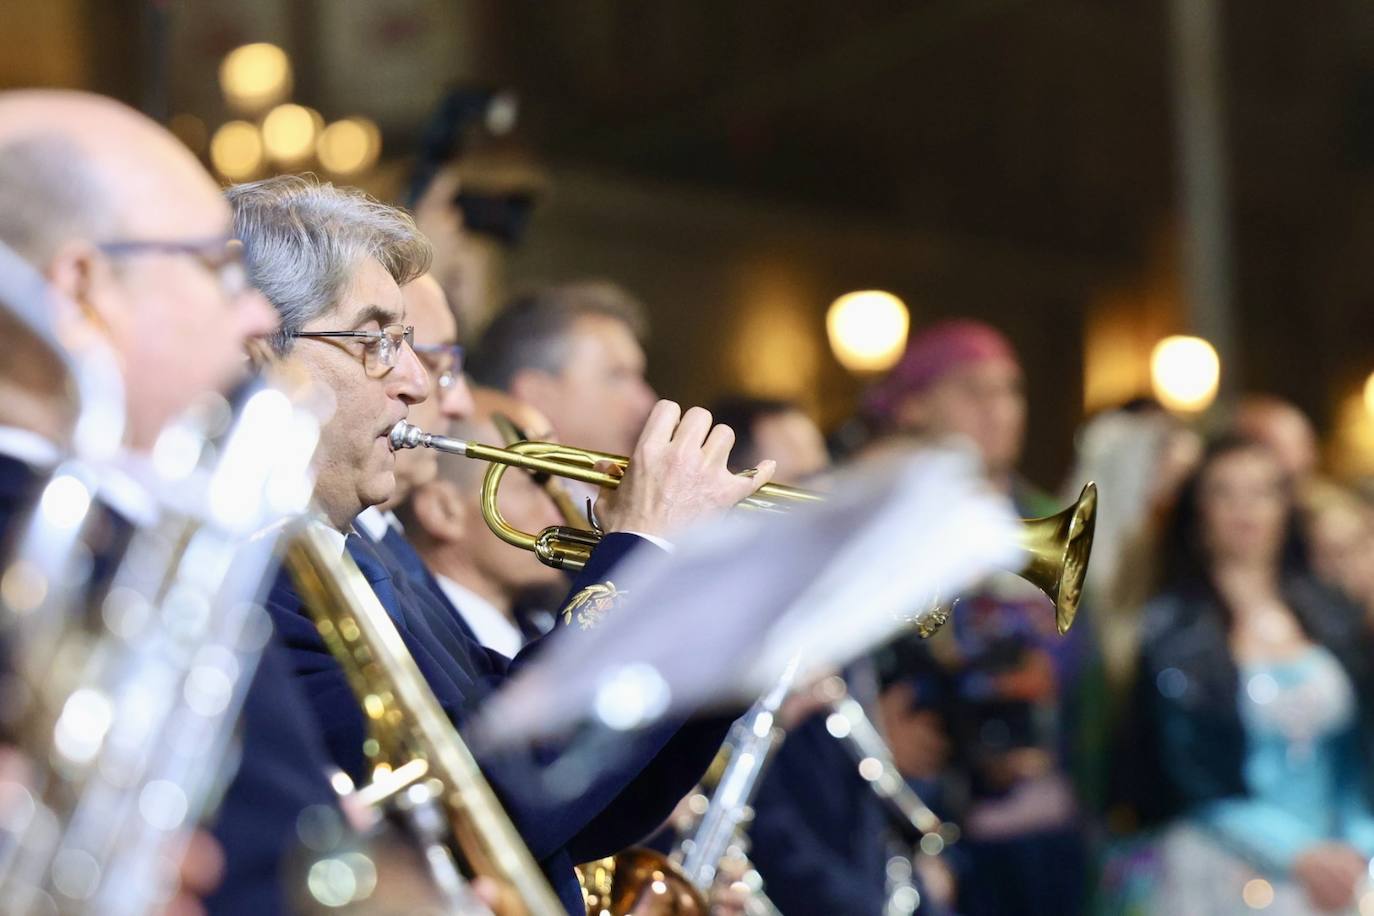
0 241 319 916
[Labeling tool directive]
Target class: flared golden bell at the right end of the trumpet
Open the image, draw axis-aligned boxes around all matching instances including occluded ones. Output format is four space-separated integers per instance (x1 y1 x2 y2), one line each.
1021 482 1098 636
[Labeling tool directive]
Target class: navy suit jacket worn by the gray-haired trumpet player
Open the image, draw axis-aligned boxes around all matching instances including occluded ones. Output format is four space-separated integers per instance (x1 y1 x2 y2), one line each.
268 534 730 916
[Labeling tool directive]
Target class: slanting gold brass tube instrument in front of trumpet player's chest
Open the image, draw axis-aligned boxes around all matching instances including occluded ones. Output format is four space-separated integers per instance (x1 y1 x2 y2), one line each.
286 523 566 916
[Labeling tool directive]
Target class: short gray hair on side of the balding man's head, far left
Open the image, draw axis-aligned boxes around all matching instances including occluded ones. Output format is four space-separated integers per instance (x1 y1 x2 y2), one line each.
0 133 120 268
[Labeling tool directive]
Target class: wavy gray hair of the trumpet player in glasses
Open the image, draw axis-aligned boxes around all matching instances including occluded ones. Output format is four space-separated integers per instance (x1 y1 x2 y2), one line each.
225 174 433 354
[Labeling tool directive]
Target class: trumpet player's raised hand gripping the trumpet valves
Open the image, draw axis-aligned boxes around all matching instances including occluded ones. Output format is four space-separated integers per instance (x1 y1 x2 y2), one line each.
596 401 775 537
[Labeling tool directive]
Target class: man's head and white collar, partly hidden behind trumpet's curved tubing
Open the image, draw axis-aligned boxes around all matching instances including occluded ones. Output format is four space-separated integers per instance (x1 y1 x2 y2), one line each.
401 389 565 658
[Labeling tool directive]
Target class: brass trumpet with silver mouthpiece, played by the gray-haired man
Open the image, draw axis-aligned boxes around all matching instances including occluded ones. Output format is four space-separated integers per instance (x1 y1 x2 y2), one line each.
390 420 1098 636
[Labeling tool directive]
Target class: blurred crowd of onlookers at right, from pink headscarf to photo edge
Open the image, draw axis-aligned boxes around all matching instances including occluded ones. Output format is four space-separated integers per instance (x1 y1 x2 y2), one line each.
785 321 1374 916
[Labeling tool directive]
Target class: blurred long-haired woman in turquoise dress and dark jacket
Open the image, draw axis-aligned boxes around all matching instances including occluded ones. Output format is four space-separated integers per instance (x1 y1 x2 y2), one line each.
1132 437 1374 916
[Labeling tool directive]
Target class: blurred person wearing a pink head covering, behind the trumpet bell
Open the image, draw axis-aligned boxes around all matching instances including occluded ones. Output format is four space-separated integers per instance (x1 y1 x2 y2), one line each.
867 320 1103 916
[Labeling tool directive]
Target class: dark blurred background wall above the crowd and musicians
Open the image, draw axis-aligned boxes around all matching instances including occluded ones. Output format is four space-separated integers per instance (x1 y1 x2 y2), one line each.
0 0 1374 483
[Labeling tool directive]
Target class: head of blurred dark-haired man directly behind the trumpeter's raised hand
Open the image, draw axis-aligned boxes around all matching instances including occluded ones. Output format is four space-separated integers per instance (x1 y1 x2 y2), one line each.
469 282 654 455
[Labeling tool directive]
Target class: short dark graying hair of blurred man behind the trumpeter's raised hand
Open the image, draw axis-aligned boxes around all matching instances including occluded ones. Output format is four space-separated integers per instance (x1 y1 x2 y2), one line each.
464 280 649 390
